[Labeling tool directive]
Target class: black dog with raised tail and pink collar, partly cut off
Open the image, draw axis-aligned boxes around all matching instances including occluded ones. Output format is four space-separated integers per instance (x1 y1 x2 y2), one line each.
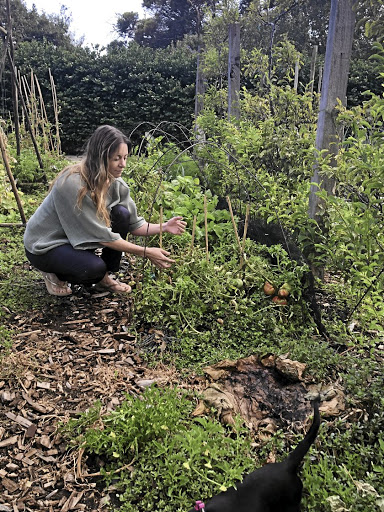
190 400 320 512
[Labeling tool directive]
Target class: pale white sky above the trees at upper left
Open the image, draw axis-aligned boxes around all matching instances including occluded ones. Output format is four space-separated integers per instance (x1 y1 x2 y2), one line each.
24 0 145 46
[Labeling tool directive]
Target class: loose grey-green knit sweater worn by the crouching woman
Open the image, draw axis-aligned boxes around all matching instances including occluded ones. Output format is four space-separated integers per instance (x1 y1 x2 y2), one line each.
24 173 145 254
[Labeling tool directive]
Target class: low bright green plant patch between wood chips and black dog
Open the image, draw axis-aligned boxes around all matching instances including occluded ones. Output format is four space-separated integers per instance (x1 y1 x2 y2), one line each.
63 387 255 512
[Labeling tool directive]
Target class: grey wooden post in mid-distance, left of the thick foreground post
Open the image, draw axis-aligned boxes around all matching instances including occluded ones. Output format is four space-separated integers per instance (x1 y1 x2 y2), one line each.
228 23 240 119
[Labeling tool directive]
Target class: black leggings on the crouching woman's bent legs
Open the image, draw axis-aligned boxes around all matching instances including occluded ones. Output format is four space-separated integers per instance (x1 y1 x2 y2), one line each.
25 205 129 285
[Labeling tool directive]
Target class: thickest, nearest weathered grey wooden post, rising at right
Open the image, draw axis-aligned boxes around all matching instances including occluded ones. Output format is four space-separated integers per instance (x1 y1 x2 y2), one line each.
309 0 356 221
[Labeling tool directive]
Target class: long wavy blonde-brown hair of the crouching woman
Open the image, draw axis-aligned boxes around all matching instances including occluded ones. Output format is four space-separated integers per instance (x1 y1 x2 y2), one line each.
54 125 132 226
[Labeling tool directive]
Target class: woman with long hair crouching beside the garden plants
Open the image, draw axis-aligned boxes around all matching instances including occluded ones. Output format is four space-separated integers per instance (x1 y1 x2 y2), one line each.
24 125 186 296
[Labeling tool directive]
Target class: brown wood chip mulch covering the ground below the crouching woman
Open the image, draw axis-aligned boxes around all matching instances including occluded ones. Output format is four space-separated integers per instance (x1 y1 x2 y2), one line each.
0 285 183 512
